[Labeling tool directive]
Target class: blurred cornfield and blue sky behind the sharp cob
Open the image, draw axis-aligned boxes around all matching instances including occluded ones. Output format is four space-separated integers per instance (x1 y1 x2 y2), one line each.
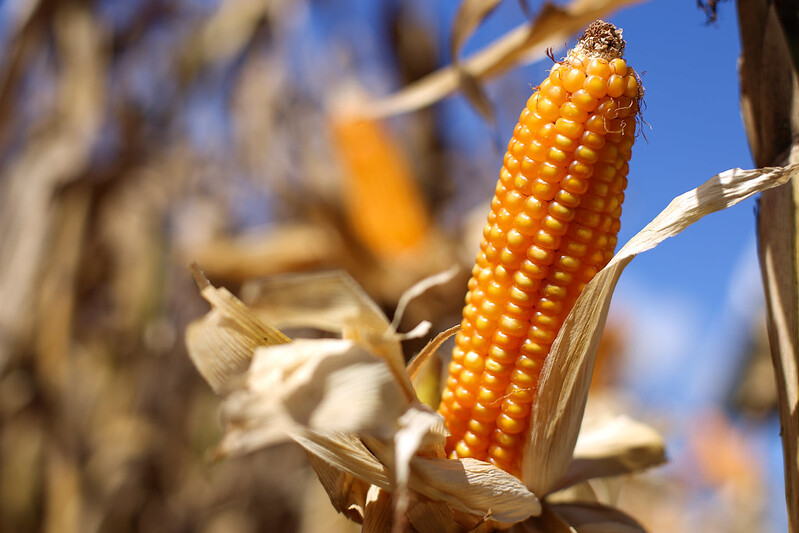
0 0 799 533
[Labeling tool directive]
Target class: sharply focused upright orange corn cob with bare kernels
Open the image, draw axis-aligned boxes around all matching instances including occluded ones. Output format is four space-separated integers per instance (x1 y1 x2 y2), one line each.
439 21 642 475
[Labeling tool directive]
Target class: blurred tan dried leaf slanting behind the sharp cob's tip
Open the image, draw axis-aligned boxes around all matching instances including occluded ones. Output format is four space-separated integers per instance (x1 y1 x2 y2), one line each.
361 0 641 117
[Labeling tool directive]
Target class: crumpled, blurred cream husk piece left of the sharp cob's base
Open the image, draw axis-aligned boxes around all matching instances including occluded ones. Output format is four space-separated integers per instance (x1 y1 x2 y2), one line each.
220 339 407 453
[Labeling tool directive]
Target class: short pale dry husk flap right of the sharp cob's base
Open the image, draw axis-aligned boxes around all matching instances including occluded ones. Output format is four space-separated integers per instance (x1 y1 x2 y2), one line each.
558 416 666 488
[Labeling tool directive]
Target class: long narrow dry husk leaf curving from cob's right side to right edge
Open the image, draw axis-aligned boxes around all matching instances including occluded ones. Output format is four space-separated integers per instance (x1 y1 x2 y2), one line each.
522 165 799 494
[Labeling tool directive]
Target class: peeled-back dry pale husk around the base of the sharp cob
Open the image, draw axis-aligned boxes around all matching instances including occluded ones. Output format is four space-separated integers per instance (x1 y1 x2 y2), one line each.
186 165 799 533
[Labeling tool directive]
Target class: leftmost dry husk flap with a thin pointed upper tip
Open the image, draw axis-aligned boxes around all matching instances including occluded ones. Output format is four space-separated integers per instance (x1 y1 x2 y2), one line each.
186 266 291 394
